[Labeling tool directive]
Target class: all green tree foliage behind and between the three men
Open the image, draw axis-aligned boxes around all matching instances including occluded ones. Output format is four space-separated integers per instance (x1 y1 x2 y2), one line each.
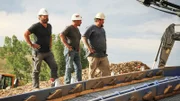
0 34 88 82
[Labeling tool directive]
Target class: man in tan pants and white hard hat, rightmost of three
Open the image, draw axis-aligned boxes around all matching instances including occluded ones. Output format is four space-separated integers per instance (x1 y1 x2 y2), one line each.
82 13 110 79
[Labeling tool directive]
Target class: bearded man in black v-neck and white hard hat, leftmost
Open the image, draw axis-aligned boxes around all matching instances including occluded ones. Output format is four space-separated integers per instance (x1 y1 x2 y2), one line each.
24 8 59 88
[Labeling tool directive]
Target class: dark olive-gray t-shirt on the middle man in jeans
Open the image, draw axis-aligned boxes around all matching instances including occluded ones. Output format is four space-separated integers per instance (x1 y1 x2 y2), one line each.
61 25 81 51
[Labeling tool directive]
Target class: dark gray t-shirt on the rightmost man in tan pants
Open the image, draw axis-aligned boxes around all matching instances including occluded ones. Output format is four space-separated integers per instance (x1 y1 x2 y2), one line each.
83 25 107 57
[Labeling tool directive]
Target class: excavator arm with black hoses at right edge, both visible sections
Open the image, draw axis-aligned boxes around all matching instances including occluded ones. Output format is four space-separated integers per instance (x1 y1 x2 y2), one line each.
137 0 180 68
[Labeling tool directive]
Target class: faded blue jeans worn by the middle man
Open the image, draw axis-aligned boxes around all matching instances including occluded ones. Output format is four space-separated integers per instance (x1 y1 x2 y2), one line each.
64 50 82 84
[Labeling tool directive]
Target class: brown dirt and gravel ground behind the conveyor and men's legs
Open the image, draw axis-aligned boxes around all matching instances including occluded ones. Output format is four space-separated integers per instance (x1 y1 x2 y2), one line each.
0 61 150 98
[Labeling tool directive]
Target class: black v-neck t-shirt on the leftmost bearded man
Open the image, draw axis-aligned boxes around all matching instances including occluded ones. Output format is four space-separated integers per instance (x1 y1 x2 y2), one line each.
28 22 52 52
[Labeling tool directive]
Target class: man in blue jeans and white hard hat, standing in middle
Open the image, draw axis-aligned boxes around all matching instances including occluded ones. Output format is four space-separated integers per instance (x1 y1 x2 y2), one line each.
60 13 82 84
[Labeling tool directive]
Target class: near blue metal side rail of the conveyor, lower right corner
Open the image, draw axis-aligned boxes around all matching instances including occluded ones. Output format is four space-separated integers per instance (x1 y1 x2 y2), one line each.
89 76 180 101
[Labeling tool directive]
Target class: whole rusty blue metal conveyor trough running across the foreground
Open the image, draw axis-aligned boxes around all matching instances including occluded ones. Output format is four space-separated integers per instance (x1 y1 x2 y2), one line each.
0 66 180 101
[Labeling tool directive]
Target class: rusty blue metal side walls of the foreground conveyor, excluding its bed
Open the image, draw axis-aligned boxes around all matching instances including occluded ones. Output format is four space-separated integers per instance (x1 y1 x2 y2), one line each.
0 66 180 101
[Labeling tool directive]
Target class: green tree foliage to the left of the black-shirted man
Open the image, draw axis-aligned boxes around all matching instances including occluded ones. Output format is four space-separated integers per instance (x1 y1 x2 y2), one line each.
0 35 31 82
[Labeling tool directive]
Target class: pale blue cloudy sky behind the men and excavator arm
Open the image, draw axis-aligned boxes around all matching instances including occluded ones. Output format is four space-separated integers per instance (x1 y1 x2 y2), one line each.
0 0 180 67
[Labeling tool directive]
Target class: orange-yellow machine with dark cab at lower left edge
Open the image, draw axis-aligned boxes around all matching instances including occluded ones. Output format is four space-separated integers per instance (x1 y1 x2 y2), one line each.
0 74 19 89
